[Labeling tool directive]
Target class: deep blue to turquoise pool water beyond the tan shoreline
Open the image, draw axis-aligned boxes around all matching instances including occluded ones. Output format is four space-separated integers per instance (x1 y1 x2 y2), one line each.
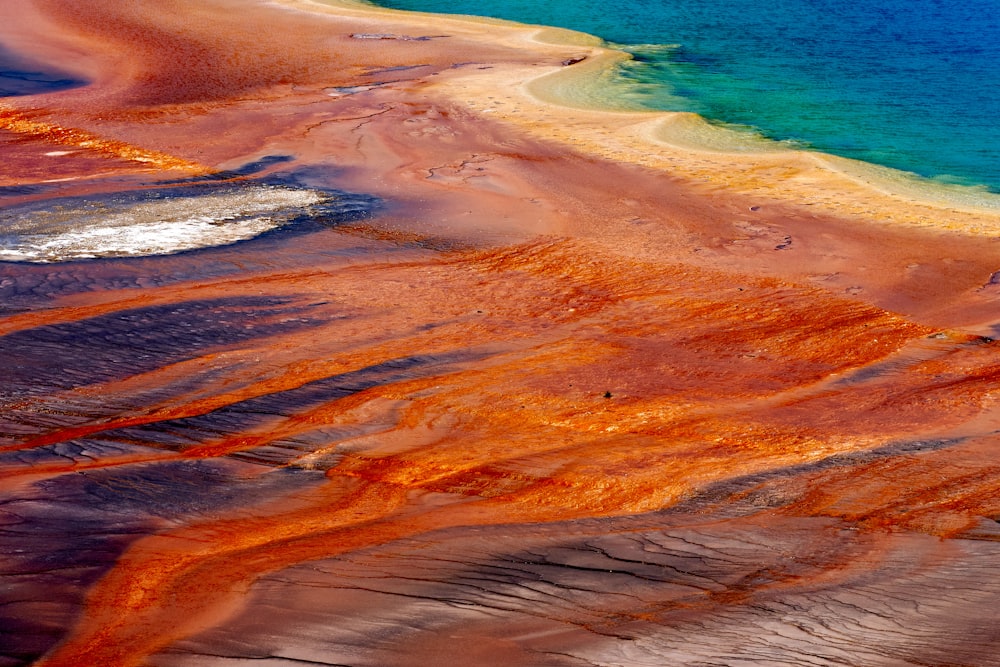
378 0 1000 192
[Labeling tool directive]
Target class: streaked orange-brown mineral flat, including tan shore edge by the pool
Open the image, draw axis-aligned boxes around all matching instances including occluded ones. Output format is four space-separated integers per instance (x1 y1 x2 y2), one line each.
0 0 1000 667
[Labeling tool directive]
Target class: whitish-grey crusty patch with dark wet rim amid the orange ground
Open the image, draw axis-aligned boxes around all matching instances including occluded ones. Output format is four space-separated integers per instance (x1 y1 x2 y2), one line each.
0 172 376 263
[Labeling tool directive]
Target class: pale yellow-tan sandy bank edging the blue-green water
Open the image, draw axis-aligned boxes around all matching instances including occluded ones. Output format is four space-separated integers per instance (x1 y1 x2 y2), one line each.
281 0 1000 235
